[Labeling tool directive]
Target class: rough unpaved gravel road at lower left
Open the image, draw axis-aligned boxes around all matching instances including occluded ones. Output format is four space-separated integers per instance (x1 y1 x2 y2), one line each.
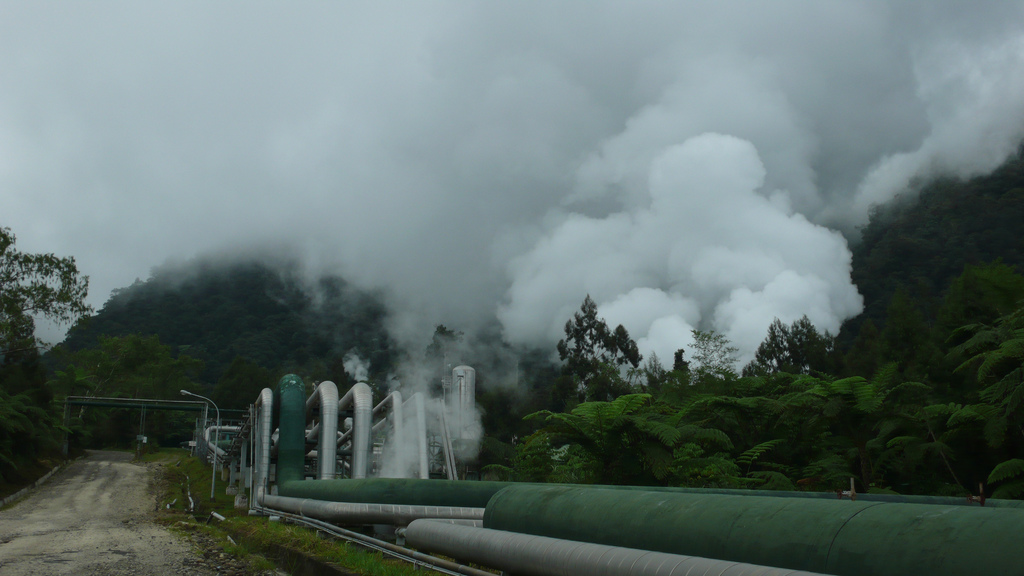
0 451 214 576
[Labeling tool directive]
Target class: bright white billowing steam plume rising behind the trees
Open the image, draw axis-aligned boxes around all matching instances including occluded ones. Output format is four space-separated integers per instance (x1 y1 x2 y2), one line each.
500 133 862 361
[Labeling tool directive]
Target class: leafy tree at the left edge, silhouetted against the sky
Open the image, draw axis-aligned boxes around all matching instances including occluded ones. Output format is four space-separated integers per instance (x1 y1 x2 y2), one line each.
0 228 92 356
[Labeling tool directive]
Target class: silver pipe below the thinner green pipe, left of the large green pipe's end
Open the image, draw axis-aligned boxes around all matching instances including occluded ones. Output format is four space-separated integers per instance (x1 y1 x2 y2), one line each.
263 487 483 526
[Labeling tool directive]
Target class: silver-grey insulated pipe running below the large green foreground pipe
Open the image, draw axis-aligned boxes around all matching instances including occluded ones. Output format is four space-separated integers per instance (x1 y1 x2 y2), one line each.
403 520 821 576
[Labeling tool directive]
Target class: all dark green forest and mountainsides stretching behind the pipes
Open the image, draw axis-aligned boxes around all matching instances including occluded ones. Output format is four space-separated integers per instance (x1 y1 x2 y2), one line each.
0 145 1024 496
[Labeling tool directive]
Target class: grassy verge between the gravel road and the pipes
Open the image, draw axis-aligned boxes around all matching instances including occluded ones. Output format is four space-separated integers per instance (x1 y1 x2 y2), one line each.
149 448 422 576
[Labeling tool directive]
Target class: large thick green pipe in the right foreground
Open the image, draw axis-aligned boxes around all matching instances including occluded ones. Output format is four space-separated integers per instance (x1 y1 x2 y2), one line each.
483 486 1024 576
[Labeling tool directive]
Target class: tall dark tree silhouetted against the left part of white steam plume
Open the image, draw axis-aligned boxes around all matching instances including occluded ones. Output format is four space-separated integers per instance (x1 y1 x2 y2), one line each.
558 294 642 401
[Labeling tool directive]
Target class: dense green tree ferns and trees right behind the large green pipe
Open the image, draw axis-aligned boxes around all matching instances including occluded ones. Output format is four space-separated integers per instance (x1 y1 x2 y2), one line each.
488 282 1024 497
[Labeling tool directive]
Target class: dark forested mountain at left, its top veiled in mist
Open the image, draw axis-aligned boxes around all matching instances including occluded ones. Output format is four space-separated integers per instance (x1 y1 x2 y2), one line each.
62 260 392 385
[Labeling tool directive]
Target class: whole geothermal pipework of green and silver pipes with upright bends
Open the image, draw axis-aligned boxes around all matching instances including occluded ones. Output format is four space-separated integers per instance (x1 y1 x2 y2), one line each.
199 366 1024 576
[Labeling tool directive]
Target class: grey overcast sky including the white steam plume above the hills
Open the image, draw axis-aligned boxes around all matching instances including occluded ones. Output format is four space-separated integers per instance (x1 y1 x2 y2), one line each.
6 0 1024 360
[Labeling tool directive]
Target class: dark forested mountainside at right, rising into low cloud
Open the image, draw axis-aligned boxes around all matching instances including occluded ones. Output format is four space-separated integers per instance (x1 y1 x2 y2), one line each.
844 148 1024 341
